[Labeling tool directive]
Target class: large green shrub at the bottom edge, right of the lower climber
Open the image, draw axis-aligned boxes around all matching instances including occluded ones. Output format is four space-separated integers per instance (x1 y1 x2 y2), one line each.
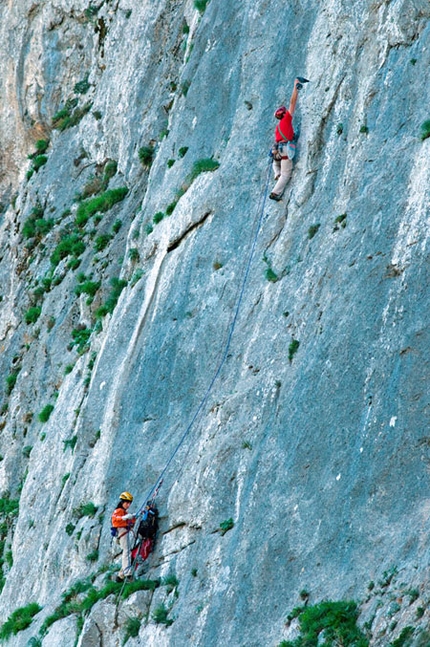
281 602 369 647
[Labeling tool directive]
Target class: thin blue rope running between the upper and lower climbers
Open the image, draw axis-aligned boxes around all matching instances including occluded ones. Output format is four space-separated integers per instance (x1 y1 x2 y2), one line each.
136 159 271 517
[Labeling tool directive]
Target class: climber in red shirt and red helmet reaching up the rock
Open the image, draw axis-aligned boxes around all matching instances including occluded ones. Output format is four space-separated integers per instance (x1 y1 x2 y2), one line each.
269 78 307 200
